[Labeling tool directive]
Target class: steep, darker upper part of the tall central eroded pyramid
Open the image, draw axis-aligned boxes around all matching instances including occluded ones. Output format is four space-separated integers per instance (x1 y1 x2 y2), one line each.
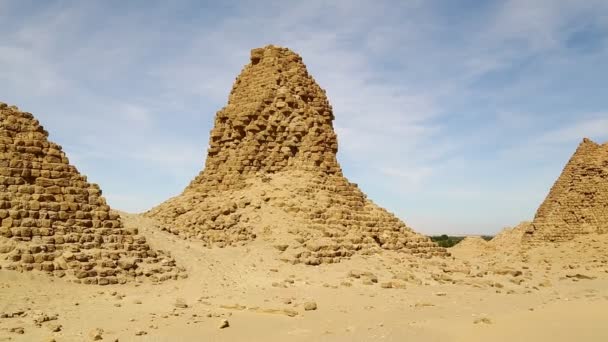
190 45 341 189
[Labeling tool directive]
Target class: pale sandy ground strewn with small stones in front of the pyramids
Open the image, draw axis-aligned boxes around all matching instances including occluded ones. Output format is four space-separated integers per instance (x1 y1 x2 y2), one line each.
0 215 608 341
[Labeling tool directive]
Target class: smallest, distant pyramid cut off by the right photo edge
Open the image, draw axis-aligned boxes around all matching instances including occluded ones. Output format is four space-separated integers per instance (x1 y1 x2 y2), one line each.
523 139 608 243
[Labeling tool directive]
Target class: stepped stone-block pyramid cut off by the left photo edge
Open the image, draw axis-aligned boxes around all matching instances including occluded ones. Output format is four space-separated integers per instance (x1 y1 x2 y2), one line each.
0 103 185 285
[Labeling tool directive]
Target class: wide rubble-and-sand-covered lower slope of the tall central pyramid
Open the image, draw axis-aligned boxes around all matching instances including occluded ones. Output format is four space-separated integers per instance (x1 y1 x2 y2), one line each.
145 171 448 265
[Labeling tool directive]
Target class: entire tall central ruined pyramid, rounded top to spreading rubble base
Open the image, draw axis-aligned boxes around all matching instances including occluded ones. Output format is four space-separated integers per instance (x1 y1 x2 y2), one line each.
146 45 446 265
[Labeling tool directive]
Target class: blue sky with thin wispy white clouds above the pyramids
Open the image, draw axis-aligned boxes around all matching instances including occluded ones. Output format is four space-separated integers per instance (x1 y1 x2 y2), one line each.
0 0 608 234
